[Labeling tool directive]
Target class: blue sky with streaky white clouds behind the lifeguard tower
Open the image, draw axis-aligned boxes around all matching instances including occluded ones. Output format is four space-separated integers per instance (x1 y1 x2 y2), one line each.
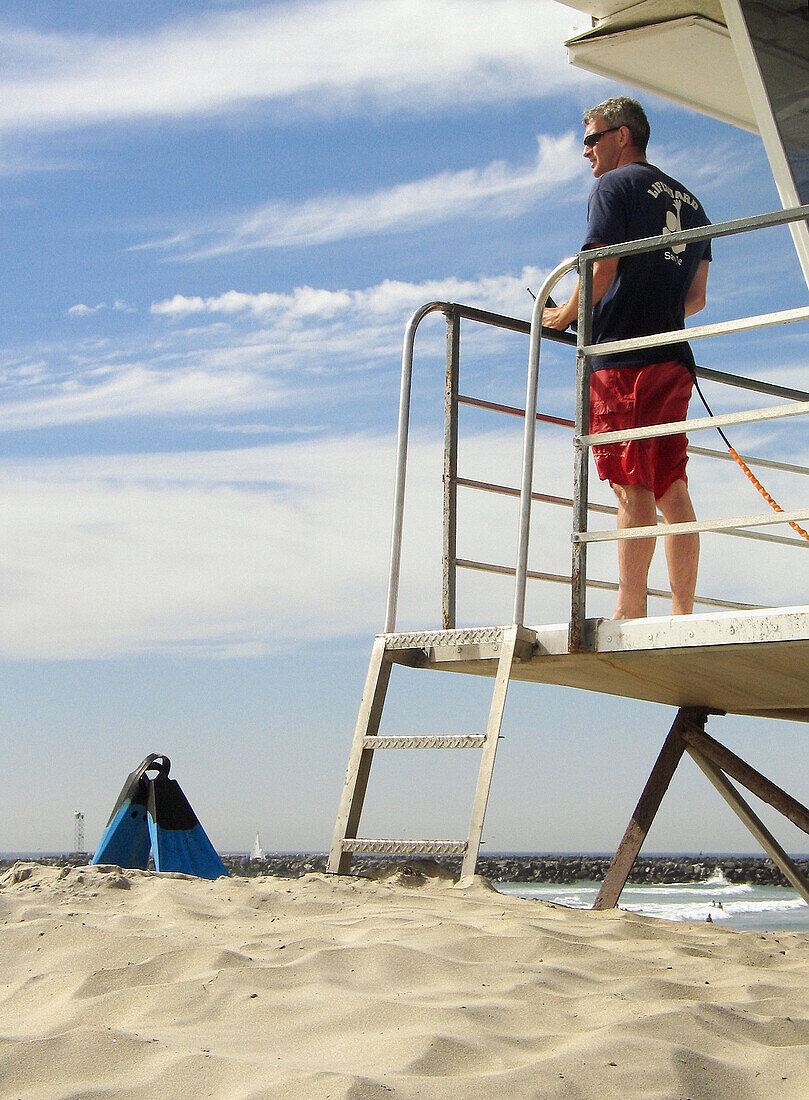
0 0 809 851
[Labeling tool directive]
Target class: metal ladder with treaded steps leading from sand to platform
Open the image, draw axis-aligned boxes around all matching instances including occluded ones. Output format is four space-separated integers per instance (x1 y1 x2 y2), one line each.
327 625 536 878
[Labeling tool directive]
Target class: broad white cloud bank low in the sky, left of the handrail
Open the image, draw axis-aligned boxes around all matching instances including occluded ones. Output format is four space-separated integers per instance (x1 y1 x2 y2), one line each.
0 438 402 658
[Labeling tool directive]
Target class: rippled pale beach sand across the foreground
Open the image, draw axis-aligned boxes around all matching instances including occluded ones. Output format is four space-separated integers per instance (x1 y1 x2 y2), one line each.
0 864 809 1100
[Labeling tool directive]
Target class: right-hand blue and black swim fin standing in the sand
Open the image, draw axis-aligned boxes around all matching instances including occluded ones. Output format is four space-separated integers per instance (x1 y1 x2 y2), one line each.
147 774 228 879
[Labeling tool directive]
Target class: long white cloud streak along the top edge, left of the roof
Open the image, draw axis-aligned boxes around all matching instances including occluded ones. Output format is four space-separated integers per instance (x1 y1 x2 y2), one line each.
0 0 583 129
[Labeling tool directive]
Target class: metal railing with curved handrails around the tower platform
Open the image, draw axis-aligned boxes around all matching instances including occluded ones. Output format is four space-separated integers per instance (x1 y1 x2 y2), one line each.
385 206 809 650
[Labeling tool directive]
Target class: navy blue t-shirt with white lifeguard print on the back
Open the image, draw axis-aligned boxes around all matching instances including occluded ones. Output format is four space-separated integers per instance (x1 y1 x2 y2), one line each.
582 163 711 371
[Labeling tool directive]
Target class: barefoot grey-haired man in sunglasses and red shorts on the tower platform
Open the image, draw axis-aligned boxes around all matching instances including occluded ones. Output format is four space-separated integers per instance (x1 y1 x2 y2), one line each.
543 96 711 619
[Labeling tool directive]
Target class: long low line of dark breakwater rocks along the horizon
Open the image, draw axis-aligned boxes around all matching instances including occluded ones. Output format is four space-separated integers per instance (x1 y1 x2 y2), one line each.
223 855 809 886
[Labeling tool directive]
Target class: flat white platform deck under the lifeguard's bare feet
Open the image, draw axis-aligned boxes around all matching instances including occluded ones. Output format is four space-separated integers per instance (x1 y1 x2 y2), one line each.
383 606 809 722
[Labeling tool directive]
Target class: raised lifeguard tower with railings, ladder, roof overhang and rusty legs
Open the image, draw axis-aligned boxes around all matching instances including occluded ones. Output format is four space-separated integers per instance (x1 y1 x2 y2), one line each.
328 0 809 909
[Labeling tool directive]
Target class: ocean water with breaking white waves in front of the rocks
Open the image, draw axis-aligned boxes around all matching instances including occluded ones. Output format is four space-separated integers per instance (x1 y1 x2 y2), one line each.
496 871 809 932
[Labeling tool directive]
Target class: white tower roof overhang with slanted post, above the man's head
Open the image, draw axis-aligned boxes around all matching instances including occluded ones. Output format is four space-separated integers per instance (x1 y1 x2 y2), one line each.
567 0 809 286
